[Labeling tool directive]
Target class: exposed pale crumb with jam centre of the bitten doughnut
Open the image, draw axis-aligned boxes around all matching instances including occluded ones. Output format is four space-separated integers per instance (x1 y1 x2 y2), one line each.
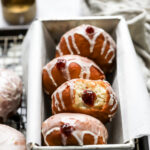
74 80 108 109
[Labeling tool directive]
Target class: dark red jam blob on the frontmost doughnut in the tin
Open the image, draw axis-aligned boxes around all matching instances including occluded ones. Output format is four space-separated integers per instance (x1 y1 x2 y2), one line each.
60 123 75 136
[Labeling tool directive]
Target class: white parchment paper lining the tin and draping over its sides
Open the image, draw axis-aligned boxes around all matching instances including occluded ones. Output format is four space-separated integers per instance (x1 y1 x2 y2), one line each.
23 17 150 148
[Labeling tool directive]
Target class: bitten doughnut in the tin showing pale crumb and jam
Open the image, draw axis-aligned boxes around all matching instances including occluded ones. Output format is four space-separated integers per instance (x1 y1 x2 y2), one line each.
52 79 118 123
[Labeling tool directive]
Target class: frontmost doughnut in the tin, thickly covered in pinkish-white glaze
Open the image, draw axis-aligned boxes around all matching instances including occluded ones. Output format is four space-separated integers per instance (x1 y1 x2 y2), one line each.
42 113 108 146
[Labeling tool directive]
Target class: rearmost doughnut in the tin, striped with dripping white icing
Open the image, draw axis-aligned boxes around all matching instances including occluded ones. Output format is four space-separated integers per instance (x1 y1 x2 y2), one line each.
56 24 116 73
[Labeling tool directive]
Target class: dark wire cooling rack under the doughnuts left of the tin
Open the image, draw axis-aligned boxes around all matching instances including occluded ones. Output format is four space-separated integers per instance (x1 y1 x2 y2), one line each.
0 31 27 134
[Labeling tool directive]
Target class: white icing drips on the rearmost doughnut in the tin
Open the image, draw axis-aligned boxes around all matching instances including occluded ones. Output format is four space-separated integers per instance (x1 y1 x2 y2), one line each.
56 25 115 63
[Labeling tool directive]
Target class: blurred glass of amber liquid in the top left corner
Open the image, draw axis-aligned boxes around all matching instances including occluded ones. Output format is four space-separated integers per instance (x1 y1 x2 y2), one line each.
2 0 36 24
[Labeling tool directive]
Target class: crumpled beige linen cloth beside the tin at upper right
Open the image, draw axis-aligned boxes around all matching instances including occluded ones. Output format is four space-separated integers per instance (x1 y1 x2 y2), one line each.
82 0 150 94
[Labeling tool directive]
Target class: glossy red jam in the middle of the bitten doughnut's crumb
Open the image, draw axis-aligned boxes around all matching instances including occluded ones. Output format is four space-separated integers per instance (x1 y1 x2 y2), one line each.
82 90 96 106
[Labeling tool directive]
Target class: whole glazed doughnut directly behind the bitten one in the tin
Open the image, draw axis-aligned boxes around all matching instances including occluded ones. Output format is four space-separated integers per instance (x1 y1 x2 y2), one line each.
43 55 105 95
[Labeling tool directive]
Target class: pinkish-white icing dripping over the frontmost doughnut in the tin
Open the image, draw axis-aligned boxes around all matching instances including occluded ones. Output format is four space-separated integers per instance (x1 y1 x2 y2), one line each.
42 113 108 145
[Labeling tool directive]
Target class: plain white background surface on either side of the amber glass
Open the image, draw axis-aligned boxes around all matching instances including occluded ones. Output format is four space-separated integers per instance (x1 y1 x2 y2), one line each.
0 0 82 28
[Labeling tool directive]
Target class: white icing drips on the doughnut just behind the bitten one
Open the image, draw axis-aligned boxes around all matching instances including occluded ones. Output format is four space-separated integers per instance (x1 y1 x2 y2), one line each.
43 55 103 87
